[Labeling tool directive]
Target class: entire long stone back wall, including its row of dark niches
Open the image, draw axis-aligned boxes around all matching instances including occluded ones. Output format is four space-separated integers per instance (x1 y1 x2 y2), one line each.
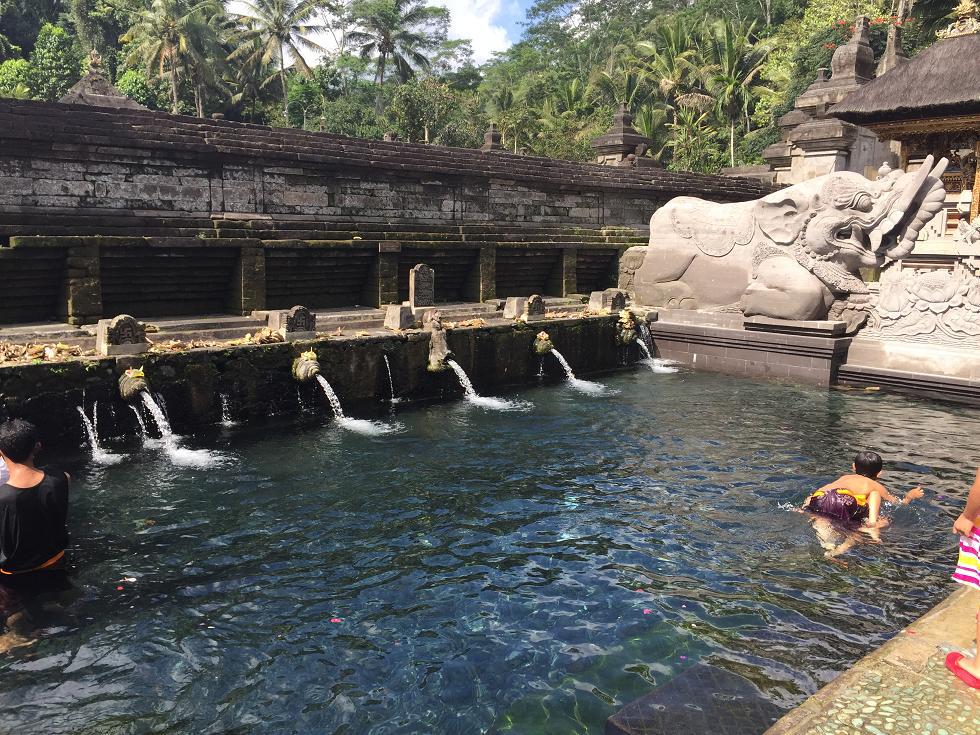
0 100 769 324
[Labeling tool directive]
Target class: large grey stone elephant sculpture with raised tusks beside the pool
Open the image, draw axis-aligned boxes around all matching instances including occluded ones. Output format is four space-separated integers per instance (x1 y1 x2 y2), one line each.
633 156 947 320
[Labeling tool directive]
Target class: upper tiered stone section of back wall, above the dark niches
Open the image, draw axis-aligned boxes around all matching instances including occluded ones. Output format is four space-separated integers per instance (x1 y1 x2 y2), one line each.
0 100 769 237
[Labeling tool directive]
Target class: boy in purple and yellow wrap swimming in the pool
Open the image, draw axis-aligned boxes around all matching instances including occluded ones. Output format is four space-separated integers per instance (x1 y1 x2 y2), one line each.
803 452 924 558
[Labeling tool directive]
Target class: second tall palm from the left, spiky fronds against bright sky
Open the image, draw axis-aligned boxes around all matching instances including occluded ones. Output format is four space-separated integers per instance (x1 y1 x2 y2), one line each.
229 0 327 115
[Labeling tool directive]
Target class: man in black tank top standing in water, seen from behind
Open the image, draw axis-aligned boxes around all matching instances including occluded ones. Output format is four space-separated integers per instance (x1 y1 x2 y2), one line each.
0 419 69 653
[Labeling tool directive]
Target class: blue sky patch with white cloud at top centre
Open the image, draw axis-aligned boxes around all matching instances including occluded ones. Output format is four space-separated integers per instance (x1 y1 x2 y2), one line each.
433 0 532 64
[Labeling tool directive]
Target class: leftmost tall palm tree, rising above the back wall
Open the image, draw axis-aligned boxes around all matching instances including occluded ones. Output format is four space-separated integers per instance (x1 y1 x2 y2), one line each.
119 0 223 115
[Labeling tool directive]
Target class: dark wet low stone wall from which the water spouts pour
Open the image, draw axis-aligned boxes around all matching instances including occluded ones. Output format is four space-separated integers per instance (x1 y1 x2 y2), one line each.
0 316 637 441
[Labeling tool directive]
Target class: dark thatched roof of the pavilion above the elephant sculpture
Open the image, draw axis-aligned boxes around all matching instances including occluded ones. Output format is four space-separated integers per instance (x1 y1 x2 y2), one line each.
829 33 980 125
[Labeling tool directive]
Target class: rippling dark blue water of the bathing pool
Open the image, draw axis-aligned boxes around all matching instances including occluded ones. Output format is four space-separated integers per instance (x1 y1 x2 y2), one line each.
0 369 980 735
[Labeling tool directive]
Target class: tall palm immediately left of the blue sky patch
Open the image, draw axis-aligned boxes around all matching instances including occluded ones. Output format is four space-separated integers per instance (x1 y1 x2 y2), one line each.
347 0 447 113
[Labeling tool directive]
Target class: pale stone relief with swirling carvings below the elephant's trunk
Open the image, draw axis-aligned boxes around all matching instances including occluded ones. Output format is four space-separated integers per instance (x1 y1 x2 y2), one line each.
861 260 980 348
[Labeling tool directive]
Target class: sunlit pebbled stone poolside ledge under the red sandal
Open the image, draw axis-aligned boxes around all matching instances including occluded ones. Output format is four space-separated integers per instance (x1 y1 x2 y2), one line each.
765 589 980 735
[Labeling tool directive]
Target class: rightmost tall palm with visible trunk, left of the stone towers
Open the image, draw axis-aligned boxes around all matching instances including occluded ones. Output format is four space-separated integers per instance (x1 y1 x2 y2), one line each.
705 21 769 166
